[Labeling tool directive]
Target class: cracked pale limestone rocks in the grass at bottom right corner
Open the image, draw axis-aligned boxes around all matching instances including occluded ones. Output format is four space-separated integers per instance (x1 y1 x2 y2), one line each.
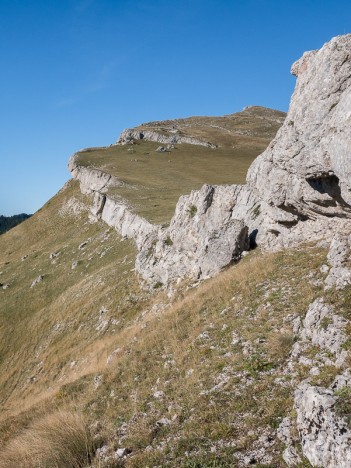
288 299 351 468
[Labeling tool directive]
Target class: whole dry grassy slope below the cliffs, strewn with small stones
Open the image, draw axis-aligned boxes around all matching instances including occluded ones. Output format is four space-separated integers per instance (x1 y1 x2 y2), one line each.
0 178 346 468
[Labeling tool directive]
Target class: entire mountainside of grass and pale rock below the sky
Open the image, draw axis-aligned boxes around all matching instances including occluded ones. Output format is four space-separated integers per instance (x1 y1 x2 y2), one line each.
0 35 351 468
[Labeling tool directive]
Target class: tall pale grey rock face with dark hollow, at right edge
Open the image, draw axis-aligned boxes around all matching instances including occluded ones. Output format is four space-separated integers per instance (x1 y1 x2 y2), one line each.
243 35 351 249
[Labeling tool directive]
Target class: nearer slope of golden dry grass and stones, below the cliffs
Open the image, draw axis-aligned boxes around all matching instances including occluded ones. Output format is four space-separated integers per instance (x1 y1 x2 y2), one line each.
0 217 334 467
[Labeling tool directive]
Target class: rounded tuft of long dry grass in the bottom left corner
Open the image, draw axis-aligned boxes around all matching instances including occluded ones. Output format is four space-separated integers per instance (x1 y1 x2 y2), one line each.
0 411 93 468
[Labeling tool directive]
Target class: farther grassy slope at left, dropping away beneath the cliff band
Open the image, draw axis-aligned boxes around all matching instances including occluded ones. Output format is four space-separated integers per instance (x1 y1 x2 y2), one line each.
0 182 148 412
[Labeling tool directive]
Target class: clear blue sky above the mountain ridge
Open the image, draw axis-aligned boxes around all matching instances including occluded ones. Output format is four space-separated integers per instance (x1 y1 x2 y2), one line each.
0 0 351 215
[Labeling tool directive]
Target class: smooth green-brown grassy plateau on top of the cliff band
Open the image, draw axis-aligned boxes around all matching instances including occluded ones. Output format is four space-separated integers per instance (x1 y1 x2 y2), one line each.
78 108 285 223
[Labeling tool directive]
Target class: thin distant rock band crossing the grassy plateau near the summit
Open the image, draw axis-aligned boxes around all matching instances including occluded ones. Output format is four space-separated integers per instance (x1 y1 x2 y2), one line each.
116 128 217 149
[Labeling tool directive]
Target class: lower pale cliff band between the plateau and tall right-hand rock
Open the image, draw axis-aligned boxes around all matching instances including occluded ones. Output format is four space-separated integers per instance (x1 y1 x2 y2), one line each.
90 185 249 286
